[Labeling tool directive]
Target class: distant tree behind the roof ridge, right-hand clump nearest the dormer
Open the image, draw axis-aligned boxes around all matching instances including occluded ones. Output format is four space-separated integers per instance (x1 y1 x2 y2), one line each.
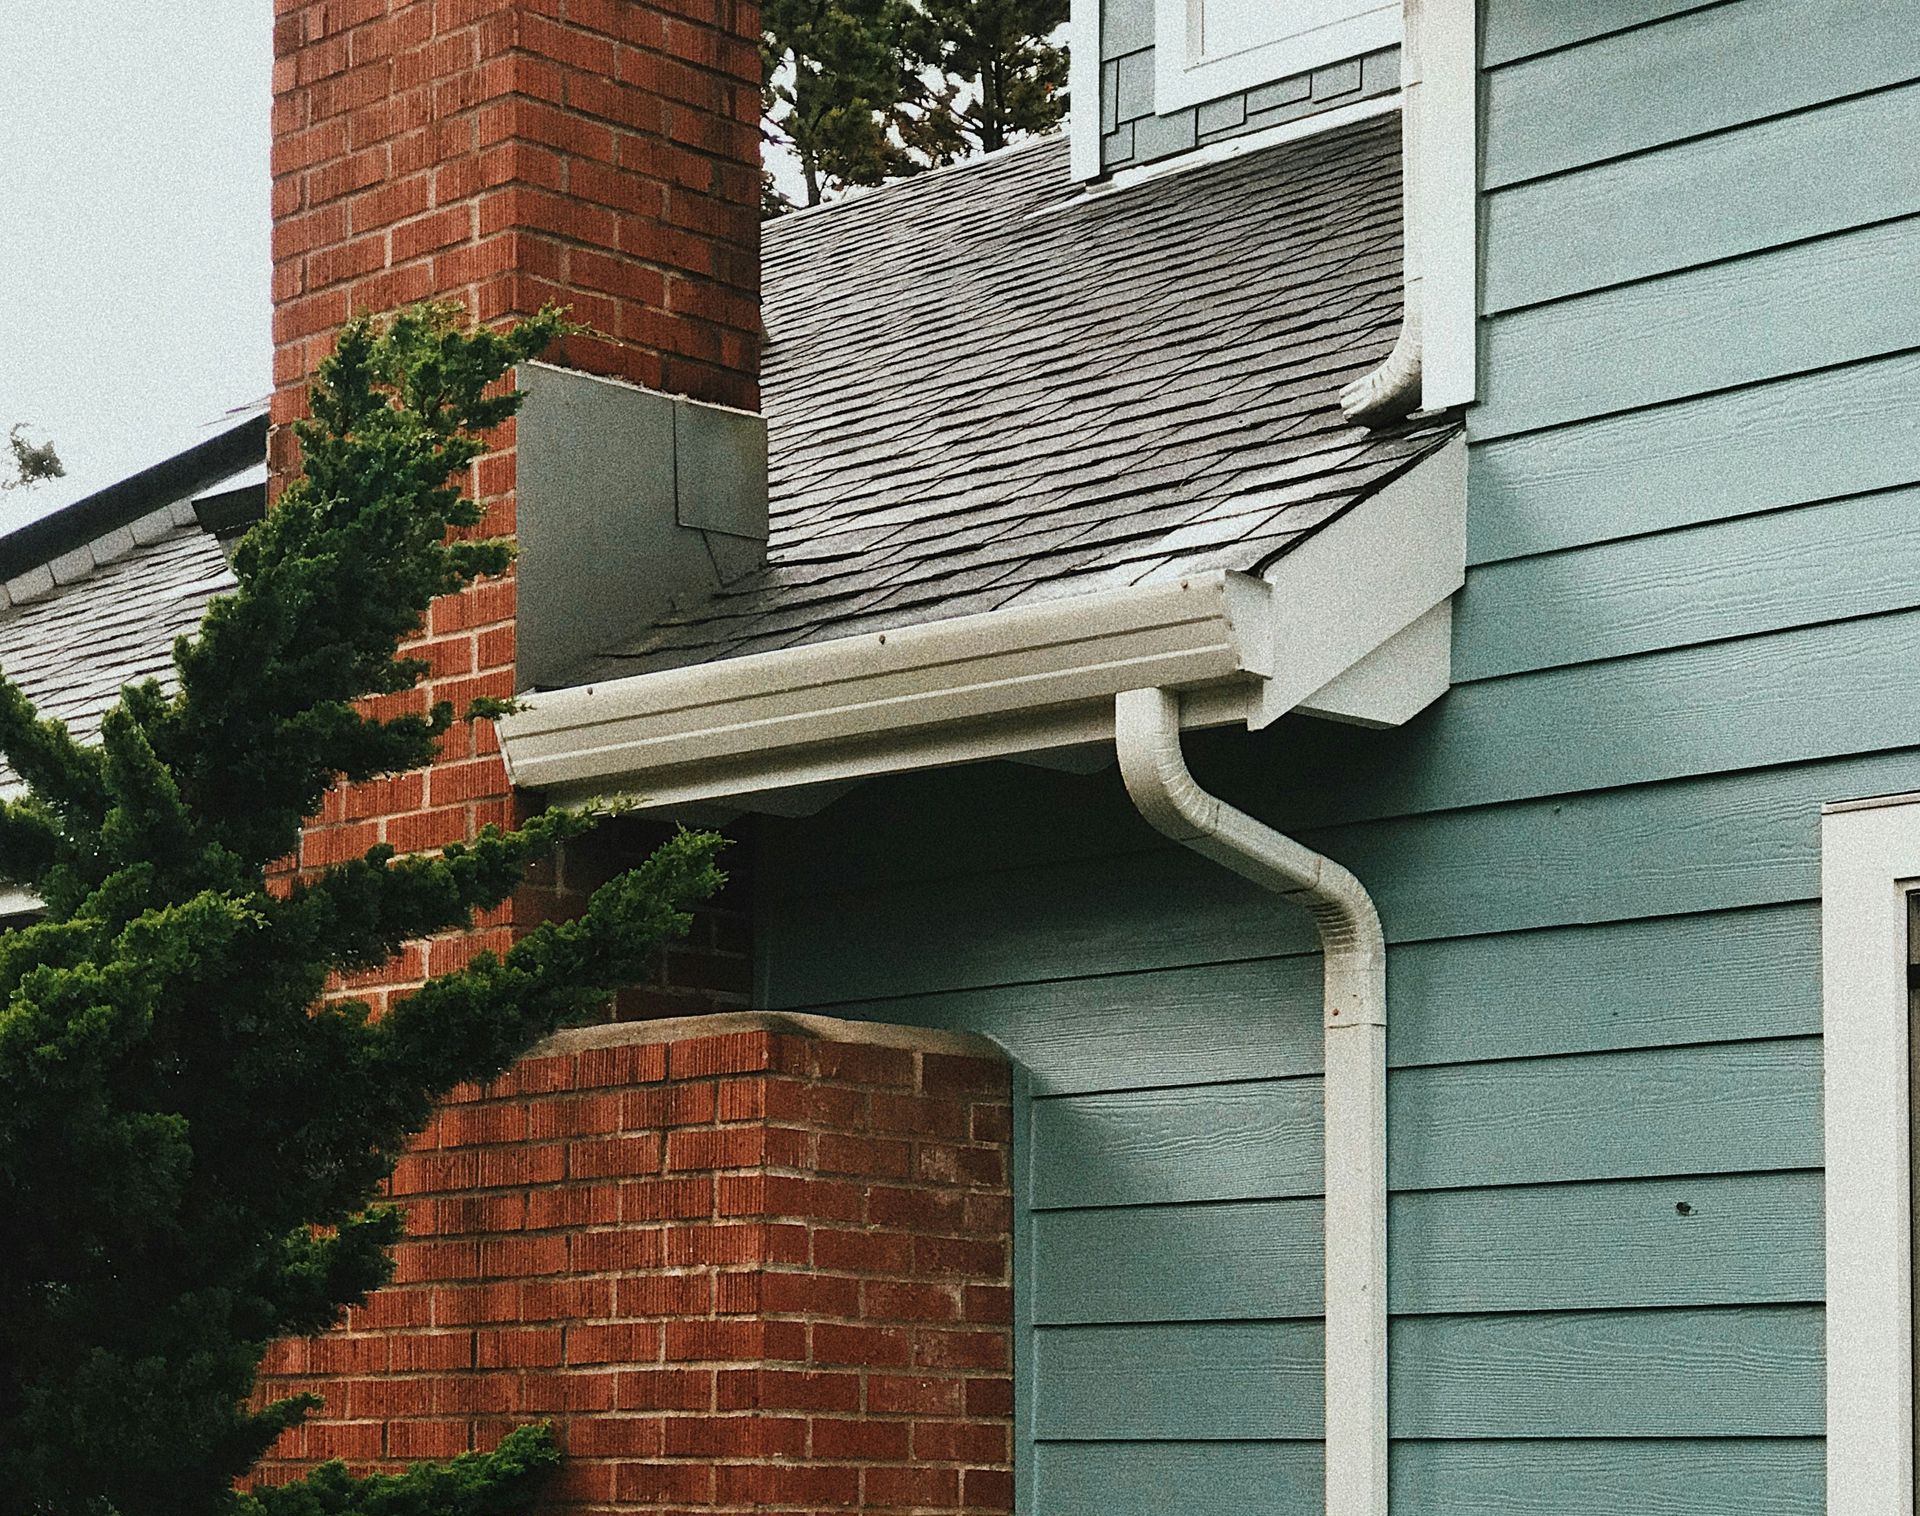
900 0 1069 163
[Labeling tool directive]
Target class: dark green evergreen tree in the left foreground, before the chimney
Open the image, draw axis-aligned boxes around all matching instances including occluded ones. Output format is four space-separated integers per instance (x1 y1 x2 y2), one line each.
0 307 718 1516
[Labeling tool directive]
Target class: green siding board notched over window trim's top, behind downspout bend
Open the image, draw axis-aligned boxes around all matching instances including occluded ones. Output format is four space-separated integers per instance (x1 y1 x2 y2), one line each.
756 752 1920 1009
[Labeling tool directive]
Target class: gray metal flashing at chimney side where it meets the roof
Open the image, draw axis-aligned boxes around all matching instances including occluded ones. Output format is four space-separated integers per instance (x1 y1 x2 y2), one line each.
515 363 768 689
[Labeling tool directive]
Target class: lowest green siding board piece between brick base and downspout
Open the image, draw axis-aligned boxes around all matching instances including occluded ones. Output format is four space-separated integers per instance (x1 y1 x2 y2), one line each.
1021 1443 1325 1516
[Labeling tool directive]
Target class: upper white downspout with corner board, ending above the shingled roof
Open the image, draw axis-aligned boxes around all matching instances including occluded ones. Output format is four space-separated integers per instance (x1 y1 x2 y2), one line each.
1340 0 1478 426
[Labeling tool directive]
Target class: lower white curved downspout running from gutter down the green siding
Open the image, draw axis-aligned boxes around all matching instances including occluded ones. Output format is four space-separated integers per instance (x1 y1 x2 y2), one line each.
1114 689 1386 1516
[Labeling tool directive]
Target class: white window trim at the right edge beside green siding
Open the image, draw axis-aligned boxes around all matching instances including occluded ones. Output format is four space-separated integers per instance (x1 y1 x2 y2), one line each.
1820 794 1920 1516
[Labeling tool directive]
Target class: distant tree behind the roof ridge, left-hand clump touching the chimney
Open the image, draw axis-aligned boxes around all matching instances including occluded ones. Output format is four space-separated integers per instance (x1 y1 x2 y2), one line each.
760 0 914 211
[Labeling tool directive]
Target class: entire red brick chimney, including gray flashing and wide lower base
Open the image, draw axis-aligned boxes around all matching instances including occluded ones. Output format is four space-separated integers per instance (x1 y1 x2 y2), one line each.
263 14 1012 1516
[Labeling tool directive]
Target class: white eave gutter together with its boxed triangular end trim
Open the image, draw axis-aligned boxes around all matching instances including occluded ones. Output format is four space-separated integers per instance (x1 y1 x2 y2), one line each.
499 438 1467 810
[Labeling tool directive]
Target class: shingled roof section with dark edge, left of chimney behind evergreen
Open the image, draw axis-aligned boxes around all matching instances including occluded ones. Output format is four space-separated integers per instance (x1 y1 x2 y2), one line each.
0 413 267 791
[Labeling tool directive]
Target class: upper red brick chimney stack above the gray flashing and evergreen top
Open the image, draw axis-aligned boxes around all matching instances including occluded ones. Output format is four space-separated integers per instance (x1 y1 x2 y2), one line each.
273 0 760 424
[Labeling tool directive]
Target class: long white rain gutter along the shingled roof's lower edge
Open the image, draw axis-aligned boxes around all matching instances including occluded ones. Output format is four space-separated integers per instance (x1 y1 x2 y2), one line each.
499 572 1273 806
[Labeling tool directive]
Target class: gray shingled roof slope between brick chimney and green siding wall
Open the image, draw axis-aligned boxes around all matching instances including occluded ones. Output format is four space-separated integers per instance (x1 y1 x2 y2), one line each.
582 115 1457 679
